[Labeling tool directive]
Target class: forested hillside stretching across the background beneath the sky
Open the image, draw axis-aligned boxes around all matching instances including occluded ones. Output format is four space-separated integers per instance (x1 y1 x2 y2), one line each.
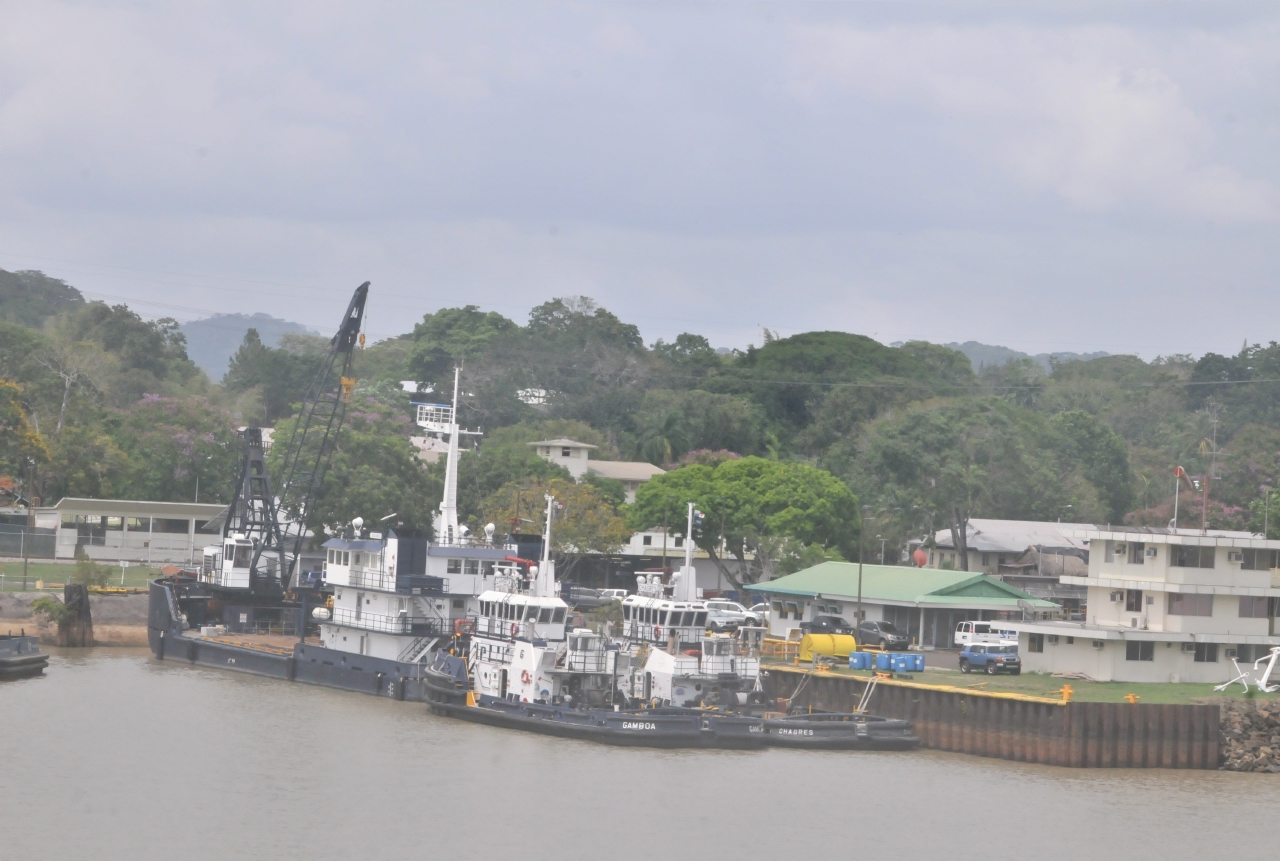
0 273 1280 557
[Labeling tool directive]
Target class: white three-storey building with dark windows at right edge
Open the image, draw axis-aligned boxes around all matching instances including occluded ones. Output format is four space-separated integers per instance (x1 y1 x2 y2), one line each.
1007 527 1280 682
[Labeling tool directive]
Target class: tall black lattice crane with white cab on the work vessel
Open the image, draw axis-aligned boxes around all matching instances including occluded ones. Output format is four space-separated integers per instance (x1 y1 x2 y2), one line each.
223 281 369 594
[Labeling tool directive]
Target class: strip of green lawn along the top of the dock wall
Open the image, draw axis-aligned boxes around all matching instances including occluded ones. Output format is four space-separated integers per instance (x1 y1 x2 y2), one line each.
762 656 1280 704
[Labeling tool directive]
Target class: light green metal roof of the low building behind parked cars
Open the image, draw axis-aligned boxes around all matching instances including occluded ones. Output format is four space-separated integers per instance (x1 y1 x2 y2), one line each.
746 562 1057 610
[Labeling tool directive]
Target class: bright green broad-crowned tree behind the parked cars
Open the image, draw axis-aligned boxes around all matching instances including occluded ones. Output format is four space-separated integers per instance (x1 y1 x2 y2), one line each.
627 457 861 587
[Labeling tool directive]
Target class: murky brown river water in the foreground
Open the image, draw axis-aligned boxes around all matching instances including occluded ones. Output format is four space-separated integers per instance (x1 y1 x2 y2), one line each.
0 649 1280 861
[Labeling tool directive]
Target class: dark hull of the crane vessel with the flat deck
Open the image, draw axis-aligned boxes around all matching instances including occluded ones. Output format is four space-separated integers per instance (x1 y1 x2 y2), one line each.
147 581 440 702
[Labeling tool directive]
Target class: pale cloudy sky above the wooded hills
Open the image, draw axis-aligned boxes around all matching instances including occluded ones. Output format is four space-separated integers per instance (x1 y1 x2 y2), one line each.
0 0 1280 358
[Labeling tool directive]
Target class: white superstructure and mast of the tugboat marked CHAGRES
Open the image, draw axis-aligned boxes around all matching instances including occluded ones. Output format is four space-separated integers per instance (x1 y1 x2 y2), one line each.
618 503 764 706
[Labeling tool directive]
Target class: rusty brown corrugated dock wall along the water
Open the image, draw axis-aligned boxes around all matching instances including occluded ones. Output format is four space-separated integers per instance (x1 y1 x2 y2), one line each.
764 668 1220 769
